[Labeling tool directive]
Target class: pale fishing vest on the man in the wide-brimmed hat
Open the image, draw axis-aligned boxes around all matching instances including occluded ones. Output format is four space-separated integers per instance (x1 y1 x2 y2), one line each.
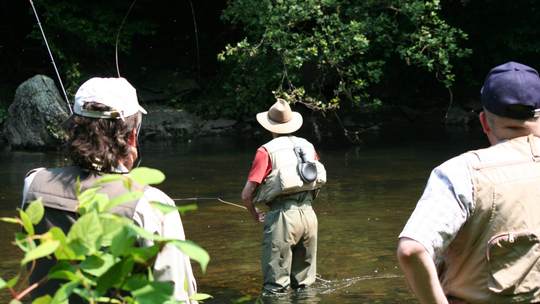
253 136 326 203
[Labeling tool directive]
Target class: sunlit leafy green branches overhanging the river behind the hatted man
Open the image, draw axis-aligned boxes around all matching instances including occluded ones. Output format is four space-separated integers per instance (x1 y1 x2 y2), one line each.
219 0 470 113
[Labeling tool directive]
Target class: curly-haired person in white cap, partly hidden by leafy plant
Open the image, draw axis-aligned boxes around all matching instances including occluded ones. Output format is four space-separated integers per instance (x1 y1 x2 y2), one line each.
23 78 197 303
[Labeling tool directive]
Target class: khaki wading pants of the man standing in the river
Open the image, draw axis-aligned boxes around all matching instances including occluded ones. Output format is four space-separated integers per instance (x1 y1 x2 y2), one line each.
261 192 318 292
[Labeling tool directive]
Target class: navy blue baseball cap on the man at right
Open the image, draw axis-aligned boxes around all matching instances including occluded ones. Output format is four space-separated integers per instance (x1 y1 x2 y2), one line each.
480 61 540 119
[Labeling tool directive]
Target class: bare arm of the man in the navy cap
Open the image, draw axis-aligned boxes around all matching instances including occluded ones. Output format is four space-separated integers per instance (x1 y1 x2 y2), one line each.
397 237 448 304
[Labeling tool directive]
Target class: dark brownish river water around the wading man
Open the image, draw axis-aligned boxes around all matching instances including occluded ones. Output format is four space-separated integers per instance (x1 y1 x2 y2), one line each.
0 124 486 304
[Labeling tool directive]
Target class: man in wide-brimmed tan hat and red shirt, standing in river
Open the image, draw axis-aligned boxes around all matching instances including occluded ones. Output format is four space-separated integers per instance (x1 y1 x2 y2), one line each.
242 99 326 293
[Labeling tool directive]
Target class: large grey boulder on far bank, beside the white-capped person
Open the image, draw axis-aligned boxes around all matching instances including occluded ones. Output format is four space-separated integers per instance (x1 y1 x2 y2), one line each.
4 75 69 148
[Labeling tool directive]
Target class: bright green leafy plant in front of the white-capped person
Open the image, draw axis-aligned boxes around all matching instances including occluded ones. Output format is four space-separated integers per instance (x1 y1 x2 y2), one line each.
0 168 210 304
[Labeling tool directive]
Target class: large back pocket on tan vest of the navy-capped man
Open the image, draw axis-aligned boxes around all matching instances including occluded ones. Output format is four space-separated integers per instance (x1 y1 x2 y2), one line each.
486 231 540 297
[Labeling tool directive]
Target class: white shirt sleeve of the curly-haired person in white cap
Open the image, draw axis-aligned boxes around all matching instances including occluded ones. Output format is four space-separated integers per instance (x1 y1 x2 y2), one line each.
133 187 197 304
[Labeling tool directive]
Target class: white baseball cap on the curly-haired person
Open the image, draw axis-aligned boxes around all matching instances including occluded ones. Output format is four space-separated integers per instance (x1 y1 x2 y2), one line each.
73 77 147 120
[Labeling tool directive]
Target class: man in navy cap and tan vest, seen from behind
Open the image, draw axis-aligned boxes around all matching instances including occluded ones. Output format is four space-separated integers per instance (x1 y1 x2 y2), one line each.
398 62 540 303
